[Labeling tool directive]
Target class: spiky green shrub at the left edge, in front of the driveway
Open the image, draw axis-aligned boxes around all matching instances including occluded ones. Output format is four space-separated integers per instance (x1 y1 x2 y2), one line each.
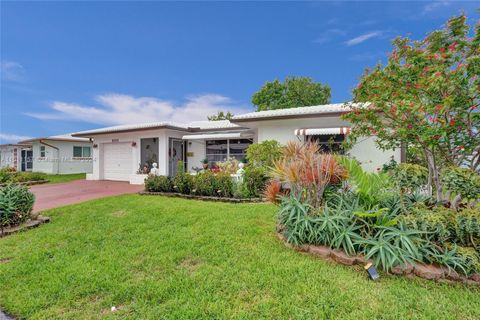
0 184 35 229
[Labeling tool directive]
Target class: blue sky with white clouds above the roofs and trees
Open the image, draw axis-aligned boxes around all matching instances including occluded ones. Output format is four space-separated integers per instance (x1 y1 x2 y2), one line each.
0 1 479 143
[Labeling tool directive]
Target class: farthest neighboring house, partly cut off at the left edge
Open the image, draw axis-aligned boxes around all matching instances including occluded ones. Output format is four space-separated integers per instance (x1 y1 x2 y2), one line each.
0 143 33 171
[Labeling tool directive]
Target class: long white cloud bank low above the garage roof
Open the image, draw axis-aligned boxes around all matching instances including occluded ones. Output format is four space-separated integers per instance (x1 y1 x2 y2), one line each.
27 93 249 125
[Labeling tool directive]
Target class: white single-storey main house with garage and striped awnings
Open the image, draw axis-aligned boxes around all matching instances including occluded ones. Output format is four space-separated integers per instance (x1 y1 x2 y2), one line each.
73 104 402 183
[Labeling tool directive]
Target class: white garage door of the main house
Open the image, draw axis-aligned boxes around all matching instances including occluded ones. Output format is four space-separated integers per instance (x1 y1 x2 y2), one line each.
103 142 132 181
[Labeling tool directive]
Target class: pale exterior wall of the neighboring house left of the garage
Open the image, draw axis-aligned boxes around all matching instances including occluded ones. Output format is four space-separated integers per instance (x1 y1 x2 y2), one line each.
32 140 93 174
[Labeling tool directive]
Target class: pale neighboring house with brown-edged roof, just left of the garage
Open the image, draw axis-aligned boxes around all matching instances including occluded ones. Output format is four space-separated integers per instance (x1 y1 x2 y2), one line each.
19 134 92 174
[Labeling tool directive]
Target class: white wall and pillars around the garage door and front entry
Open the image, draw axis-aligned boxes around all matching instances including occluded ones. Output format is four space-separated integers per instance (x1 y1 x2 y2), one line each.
89 129 186 180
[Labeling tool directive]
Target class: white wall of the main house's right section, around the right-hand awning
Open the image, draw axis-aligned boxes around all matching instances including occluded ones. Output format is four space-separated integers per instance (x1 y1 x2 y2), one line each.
244 117 401 171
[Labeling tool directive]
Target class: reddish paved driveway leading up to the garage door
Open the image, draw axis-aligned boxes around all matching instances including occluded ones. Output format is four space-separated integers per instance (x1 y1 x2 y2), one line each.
30 180 143 212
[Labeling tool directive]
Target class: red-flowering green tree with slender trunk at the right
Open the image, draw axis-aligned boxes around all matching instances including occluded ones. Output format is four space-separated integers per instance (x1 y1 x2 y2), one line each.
344 15 480 201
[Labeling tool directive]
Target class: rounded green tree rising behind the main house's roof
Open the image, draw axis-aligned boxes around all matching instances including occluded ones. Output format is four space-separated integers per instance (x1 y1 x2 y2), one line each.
252 77 331 111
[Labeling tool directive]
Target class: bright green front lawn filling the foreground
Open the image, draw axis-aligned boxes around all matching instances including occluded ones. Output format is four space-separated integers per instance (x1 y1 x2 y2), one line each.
0 195 480 319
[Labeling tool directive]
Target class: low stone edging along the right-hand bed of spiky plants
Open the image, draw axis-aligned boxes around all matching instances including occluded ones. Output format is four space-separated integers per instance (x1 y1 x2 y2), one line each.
276 232 480 286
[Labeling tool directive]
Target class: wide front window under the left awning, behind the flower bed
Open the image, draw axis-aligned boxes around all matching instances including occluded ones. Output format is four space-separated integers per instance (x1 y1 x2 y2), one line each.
205 139 252 165
